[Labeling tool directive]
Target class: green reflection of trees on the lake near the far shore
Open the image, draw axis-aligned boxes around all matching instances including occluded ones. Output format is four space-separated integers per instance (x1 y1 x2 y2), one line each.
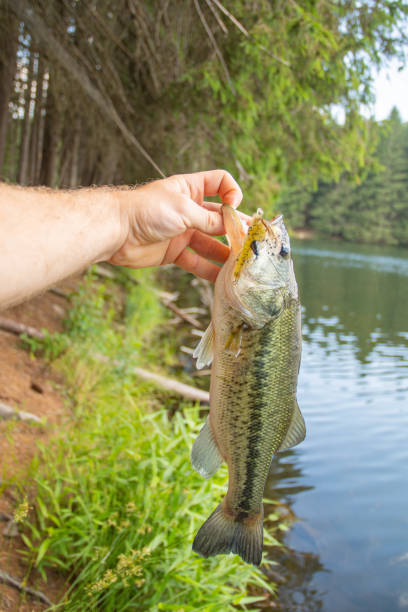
294 243 408 363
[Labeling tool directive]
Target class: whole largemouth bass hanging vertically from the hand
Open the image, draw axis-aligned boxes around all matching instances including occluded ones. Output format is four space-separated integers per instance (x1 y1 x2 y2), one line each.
191 205 306 566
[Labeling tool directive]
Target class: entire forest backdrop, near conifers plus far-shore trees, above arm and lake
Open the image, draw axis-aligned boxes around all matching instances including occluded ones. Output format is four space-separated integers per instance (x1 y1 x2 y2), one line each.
0 0 408 244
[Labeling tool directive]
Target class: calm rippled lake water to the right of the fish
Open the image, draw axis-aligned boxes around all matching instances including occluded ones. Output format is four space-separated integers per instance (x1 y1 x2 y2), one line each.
266 242 408 612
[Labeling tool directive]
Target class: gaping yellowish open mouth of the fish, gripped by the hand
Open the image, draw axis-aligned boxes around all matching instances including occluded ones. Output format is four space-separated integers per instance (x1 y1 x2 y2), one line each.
222 205 283 279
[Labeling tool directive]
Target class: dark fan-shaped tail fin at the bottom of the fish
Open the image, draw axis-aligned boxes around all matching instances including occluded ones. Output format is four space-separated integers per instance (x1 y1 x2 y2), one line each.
193 504 263 565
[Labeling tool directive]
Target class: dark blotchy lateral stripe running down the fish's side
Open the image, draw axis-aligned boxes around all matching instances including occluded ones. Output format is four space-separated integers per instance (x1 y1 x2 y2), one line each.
239 333 270 511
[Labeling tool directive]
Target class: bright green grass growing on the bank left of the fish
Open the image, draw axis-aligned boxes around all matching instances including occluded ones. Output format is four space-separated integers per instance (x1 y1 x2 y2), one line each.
23 272 276 612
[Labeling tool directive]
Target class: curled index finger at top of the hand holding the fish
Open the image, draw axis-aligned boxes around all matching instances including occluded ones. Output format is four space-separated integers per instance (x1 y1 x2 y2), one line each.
176 170 242 208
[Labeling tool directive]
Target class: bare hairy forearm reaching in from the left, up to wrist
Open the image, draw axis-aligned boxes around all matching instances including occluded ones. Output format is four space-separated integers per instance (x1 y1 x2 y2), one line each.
0 183 124 308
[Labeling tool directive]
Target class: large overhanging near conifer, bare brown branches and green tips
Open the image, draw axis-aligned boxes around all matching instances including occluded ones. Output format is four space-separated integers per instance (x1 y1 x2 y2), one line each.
0 0 408 206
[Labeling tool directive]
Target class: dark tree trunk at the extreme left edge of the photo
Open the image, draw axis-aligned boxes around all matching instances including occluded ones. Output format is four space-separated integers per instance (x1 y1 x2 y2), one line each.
0 8 18 178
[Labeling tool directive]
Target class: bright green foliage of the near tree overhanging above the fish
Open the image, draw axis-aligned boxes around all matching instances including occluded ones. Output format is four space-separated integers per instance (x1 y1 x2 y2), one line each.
164 0 407 209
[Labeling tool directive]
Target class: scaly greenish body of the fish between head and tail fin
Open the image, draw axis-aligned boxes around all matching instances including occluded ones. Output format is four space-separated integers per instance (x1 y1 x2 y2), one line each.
210 301 300 513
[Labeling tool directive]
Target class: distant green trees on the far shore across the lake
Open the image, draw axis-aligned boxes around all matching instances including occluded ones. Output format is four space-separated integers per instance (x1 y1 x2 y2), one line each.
278 110 408 245
